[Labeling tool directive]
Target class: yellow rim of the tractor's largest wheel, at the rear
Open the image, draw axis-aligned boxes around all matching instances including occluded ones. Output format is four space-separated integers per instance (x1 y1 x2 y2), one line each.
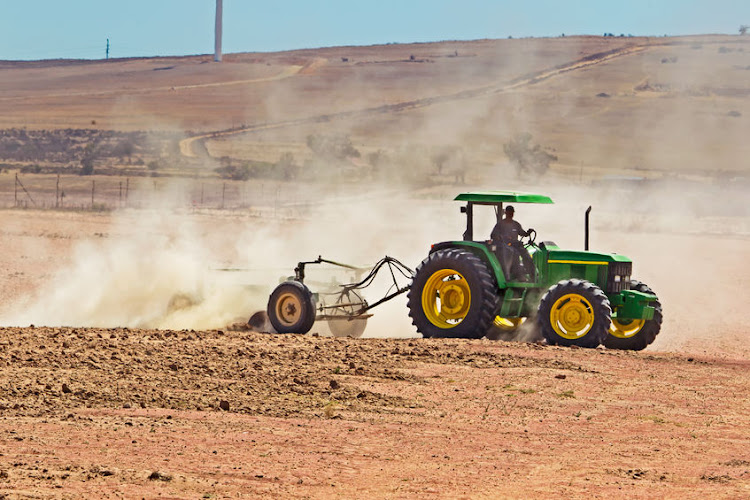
422 269 471 329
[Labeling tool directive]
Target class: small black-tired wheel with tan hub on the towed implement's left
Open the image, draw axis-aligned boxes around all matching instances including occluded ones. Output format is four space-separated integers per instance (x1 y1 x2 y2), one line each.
267 281 315 334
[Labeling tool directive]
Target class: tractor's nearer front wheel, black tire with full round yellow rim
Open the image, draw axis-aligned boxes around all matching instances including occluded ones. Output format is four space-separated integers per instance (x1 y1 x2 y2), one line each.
537 279 612 348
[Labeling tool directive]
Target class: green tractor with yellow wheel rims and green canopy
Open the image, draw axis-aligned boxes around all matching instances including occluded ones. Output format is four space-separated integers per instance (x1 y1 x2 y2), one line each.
407 191 662 350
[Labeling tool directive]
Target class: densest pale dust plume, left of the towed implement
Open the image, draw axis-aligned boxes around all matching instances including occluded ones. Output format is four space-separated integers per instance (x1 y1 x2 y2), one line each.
1 205 256 328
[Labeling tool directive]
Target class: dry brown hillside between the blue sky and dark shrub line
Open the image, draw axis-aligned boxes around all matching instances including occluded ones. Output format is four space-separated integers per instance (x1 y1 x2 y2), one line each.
0 35 750 175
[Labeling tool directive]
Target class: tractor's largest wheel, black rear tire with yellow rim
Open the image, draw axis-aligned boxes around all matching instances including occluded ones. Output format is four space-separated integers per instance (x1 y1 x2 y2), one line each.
407 248 500 339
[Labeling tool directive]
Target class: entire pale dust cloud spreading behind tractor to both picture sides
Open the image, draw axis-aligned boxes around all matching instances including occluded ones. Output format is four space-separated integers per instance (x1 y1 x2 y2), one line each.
0 172 750 356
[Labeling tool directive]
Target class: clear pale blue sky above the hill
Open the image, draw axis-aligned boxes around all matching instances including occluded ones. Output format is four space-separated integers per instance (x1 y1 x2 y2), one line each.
0 0 750 60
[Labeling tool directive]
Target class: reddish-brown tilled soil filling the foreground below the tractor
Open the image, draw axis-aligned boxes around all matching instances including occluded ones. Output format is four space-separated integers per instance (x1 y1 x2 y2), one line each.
0 328 750 498
